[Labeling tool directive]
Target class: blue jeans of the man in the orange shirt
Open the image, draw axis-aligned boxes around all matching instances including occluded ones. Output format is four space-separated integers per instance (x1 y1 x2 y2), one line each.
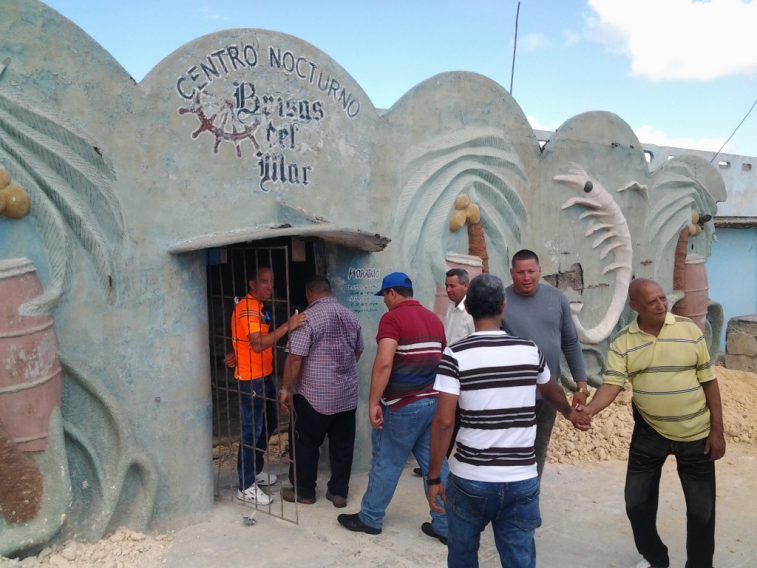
237 376 278 491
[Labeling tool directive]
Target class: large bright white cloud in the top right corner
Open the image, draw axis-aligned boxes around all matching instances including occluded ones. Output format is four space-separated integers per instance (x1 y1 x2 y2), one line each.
587 0 757 80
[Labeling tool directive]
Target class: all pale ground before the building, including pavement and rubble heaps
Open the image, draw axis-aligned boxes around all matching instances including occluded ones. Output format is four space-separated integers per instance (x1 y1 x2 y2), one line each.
0 368 757 568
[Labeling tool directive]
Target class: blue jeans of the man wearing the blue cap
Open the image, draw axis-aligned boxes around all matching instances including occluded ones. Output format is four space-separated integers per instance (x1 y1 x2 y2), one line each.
360 397 448 537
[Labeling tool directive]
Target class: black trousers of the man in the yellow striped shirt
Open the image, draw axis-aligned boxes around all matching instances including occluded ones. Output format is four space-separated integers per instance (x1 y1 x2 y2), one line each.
625 409 715 568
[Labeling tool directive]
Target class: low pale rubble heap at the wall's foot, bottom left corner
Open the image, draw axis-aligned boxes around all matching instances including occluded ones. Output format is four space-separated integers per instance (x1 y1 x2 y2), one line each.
0 528 171 568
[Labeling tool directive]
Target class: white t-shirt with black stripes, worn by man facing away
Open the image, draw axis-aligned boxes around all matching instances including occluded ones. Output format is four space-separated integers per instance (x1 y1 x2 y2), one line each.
434 331 551 483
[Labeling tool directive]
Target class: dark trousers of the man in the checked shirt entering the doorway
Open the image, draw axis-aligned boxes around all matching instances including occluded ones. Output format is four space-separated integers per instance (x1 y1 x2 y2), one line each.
289 395 355 499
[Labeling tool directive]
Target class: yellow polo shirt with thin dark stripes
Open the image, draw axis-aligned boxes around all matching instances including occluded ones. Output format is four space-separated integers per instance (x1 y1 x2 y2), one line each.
604 313 715 442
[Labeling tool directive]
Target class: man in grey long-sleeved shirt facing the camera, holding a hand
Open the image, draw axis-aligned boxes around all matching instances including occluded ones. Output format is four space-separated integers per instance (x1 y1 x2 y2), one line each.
502 249 589 477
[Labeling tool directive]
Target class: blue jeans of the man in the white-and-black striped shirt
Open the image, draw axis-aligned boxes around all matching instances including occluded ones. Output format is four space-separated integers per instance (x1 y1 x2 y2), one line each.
446 473 541 568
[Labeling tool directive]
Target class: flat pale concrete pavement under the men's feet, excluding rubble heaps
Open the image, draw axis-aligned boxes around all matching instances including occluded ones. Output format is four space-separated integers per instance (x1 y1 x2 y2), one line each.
166 447 757 568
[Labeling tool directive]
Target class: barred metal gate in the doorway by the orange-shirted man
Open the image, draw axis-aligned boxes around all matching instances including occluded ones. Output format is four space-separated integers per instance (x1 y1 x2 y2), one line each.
207 244 298 524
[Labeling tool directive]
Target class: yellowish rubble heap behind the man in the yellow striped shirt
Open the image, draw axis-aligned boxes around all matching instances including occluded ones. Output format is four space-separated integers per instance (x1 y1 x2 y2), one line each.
549 367 757 463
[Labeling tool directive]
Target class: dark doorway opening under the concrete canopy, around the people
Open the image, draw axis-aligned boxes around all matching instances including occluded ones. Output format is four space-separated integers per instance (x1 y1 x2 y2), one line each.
207 237 326 522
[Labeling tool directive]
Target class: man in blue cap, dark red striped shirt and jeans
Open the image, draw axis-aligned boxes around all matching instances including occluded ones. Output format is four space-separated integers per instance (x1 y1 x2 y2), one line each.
337 272 447 544
